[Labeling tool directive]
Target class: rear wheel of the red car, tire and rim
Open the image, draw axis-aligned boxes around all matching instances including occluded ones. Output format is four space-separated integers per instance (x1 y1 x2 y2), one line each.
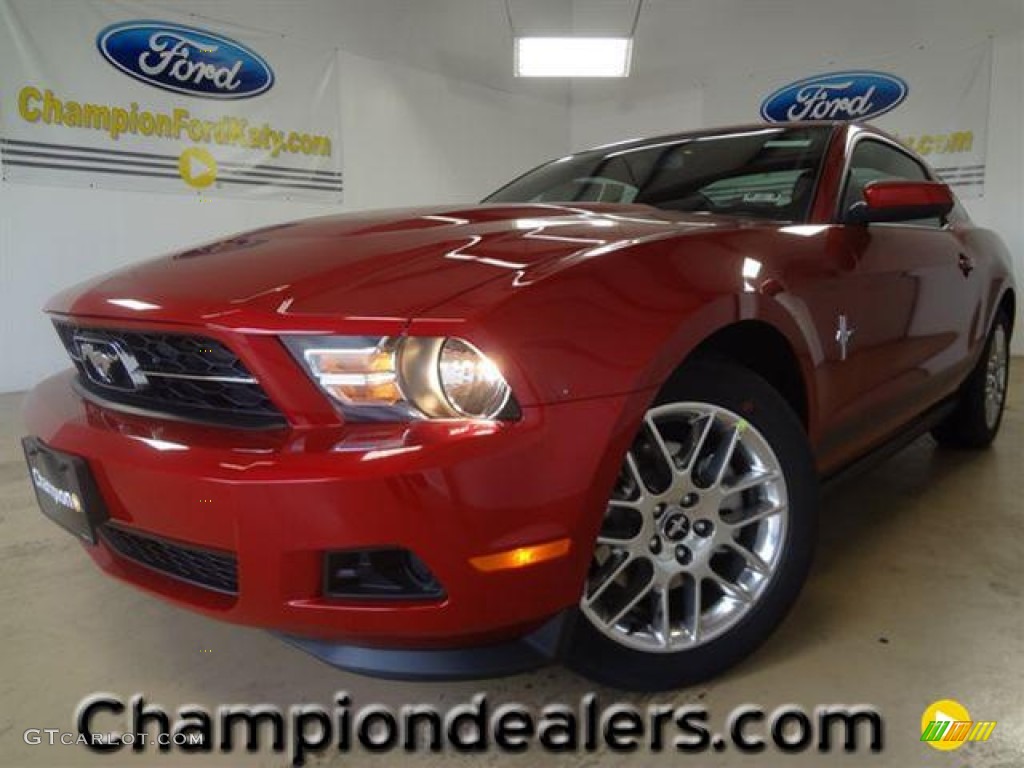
932 312 1010 450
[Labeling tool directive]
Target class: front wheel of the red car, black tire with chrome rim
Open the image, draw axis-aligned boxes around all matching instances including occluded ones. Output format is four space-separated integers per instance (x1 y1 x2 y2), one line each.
568 361 818 691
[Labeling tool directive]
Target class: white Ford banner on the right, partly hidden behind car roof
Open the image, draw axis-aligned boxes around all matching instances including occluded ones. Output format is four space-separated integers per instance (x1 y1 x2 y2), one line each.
705 40 992 198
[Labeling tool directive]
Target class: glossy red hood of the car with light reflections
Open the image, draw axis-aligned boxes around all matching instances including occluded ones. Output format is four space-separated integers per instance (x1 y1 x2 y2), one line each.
47 205 739 331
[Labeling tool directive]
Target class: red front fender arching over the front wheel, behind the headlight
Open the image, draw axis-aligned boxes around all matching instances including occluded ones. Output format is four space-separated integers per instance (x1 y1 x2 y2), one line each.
409 227 820 434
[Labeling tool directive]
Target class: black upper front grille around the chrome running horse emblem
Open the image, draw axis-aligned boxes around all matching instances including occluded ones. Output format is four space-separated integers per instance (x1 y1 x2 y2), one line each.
54 322 285 427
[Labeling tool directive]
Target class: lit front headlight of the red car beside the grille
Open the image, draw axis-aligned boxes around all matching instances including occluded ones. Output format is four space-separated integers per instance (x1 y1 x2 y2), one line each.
284 336 518 420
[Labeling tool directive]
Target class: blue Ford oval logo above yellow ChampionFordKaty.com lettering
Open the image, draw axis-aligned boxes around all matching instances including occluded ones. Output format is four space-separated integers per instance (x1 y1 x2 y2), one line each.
96 22 273 99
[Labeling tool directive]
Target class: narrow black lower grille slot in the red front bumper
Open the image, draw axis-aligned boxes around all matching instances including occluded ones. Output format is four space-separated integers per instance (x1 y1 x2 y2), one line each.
99 523 239 595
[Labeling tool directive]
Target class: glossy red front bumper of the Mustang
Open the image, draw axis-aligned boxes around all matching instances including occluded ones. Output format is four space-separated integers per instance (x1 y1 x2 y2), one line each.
25 373 631 659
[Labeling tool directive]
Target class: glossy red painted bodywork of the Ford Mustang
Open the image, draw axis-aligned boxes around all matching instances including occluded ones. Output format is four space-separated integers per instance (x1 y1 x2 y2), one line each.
26 126 1012 647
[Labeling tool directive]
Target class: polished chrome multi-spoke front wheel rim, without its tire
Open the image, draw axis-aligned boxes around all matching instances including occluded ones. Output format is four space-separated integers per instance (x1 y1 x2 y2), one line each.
581 402 788 653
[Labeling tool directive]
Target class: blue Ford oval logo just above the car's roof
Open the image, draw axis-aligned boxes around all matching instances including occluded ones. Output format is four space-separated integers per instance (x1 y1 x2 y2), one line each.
761 70 909 123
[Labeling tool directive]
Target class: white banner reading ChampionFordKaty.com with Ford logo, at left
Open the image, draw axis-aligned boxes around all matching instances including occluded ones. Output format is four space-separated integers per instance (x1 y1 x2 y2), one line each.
0 0 342 202
